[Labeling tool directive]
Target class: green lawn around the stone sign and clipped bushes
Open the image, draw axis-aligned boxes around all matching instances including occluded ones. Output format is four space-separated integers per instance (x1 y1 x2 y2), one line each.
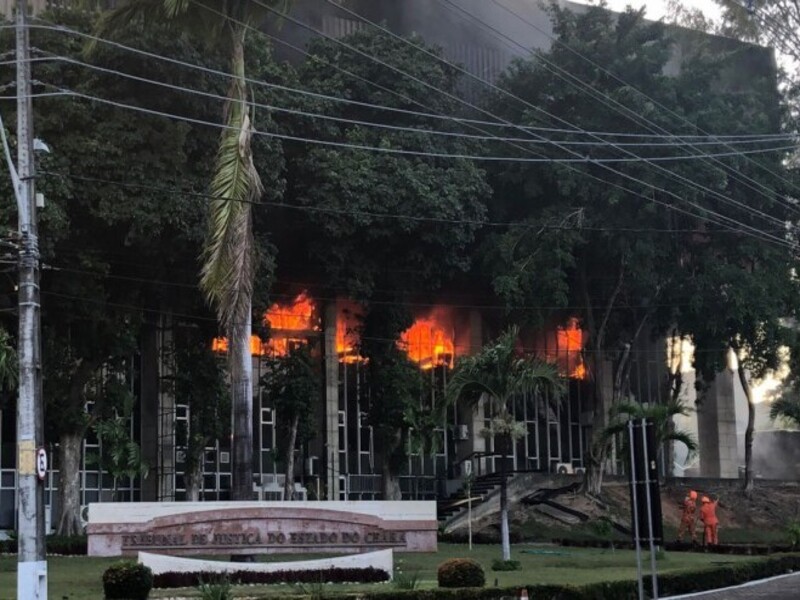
0 544 754 600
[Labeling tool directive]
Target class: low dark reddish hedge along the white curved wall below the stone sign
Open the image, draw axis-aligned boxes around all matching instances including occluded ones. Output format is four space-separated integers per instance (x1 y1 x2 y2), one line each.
153 567 389 588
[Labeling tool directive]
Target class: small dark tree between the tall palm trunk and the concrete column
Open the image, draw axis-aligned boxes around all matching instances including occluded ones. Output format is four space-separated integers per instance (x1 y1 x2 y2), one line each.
261 344 321 500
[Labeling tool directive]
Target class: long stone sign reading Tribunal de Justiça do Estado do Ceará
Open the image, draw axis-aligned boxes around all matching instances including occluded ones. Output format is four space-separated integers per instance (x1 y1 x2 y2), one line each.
86 502 437 556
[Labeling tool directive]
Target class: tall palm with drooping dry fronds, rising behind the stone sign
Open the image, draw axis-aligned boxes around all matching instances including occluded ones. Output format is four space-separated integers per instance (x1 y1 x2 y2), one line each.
98 0 288 500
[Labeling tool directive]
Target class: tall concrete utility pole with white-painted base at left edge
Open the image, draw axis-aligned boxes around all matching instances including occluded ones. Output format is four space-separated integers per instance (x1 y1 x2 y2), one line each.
16 0 47 600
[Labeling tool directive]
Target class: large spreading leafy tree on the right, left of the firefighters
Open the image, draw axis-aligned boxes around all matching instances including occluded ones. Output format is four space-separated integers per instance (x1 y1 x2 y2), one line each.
483 5 790 495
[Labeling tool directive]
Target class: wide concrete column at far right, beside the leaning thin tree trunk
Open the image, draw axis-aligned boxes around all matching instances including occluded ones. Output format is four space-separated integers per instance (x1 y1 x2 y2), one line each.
697 369 739 478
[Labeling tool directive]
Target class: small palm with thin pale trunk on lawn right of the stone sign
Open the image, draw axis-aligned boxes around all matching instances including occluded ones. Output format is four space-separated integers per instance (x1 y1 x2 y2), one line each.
447 327 563 560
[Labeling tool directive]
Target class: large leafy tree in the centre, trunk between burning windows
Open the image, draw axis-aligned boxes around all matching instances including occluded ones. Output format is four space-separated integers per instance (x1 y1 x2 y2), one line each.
274 30 490 500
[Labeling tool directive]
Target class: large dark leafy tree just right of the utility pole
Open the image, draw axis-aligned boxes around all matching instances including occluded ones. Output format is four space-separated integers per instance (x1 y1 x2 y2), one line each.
0 4 247 534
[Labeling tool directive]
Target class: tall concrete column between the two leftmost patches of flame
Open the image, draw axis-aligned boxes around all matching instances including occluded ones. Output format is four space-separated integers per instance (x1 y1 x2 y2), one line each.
322 302 339 500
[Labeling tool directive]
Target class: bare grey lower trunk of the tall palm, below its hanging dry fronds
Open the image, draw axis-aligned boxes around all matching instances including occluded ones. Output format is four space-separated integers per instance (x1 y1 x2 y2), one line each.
228 312 253 500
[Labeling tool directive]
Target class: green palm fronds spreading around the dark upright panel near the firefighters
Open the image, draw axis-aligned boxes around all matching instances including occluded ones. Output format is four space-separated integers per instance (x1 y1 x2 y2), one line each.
601 399 697 478
